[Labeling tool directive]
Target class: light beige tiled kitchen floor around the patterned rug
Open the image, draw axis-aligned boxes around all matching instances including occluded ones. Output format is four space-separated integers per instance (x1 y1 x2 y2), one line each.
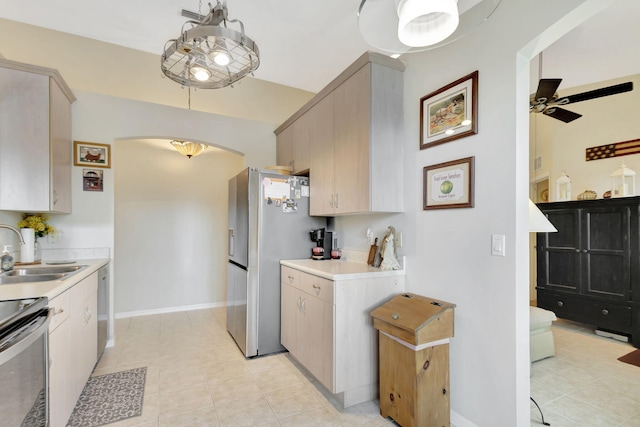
93 309 394 427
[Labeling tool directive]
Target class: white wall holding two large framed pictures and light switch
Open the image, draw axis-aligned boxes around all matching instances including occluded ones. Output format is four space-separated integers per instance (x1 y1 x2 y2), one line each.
336 0 606 427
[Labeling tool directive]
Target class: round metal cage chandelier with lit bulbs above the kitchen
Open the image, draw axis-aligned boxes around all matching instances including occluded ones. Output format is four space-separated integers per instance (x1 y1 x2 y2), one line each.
161 0 260 89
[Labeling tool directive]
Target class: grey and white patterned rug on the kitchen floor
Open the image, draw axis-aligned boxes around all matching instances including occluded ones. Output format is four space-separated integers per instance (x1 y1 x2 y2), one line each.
67 368 147 427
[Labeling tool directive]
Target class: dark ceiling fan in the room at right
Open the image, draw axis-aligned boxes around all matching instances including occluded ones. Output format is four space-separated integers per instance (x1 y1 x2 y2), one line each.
529 79 633 123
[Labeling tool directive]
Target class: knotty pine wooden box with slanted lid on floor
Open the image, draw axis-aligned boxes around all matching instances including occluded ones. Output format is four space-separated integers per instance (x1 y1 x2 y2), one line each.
371 293 455 427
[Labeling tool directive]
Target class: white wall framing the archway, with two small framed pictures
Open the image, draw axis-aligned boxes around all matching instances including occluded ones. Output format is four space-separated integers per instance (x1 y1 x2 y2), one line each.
43 91 275 324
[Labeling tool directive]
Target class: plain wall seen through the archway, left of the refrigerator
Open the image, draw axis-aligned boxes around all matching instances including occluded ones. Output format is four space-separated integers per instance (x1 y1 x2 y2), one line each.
113 140 243 315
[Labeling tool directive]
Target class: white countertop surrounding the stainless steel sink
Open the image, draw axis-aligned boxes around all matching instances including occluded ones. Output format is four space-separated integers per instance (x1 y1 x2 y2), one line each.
0 258 110 301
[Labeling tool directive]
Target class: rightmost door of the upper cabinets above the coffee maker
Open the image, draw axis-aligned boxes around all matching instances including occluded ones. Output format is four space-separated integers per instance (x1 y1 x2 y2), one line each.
334 64 375 214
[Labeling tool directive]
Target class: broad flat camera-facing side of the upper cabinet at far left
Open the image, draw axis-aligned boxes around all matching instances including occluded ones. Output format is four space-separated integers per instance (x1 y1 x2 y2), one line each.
0 68 49 212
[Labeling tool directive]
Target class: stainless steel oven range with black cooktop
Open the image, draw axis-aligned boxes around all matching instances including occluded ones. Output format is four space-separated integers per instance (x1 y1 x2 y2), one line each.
0 298 52 427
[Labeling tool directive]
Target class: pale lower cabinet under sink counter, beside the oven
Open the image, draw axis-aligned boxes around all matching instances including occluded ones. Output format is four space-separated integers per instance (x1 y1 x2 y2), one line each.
49 272 98 427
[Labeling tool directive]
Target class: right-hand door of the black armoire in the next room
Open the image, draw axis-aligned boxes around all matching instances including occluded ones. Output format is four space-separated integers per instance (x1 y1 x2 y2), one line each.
582 206 631 301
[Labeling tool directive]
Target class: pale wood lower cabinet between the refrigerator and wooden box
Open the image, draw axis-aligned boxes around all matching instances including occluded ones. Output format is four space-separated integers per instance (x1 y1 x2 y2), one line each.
281 266 404 407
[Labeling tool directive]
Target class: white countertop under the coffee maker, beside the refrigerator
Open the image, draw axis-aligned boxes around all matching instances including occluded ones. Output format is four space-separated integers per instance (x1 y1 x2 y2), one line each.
280 258 405 280
